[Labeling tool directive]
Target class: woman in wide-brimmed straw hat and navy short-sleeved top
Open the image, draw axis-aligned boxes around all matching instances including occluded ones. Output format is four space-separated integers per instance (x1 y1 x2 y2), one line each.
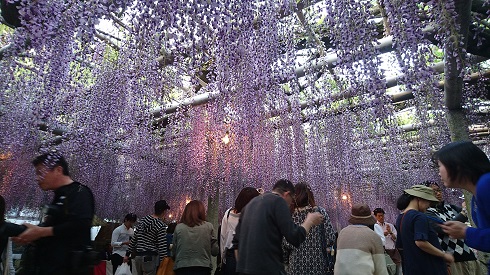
396 185 454 275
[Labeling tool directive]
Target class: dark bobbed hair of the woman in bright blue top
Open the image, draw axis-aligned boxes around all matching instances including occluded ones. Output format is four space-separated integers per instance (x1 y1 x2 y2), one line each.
432 141 490 184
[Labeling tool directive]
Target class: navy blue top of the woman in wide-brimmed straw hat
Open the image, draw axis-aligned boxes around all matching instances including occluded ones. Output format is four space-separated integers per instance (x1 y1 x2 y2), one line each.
396 210 448 275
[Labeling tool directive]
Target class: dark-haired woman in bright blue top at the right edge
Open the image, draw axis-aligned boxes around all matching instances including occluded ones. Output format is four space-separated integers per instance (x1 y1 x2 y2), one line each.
433 141 490 252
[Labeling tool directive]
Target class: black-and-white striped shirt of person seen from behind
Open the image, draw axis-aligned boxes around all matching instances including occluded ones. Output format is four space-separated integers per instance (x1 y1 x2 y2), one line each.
126 215 167 261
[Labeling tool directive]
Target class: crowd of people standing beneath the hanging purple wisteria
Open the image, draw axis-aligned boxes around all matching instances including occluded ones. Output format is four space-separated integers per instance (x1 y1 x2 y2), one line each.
0 142 490 275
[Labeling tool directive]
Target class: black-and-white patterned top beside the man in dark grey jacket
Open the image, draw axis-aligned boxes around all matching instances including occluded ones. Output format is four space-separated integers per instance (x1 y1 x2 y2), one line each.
283 206 335 275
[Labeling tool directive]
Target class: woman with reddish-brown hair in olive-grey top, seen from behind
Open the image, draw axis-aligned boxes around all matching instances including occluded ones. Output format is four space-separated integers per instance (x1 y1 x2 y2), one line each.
172 200 219 275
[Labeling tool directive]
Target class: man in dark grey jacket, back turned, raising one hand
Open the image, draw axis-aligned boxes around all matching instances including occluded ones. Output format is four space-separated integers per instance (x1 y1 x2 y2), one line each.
232 179 323 274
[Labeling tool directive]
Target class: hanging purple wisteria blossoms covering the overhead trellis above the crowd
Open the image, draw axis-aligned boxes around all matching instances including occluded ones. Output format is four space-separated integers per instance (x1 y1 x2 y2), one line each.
0 0 490 227
